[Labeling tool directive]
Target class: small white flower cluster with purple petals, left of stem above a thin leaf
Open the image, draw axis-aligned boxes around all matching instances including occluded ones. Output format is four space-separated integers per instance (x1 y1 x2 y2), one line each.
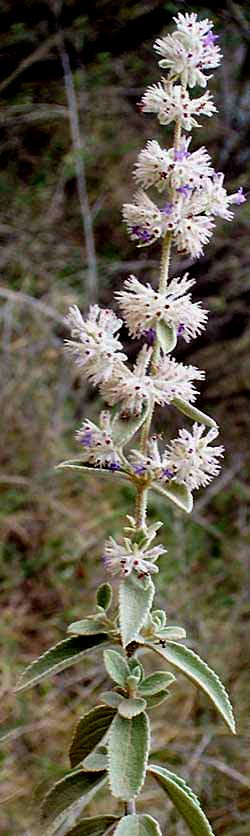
76 411 121 470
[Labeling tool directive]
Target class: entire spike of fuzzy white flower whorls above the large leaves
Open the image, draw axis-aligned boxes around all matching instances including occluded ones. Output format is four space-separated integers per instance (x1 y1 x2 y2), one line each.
63 13 245 578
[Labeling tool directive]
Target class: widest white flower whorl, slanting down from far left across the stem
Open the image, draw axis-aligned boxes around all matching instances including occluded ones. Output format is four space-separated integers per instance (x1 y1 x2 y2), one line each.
66 312 204 416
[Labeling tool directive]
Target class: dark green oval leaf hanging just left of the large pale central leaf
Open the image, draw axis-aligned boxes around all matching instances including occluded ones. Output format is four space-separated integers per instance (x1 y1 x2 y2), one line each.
69 705 115 767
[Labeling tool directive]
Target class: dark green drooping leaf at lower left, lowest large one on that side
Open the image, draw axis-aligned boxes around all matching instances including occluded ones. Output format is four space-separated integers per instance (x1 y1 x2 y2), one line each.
41 769 106 827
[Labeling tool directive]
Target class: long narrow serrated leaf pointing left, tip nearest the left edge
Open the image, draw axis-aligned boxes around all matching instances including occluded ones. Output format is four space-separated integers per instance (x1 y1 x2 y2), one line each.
15 633 107 691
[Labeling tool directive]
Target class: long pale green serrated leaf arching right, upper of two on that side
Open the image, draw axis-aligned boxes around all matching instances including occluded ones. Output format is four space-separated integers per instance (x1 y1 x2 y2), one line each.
149 642 235 734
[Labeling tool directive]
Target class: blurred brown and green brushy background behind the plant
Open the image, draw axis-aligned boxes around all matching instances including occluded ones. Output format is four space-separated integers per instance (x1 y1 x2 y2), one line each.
0 0 250 836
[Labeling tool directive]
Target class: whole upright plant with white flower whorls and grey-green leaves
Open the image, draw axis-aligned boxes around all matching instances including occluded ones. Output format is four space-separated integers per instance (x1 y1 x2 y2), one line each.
16 14 245 836
